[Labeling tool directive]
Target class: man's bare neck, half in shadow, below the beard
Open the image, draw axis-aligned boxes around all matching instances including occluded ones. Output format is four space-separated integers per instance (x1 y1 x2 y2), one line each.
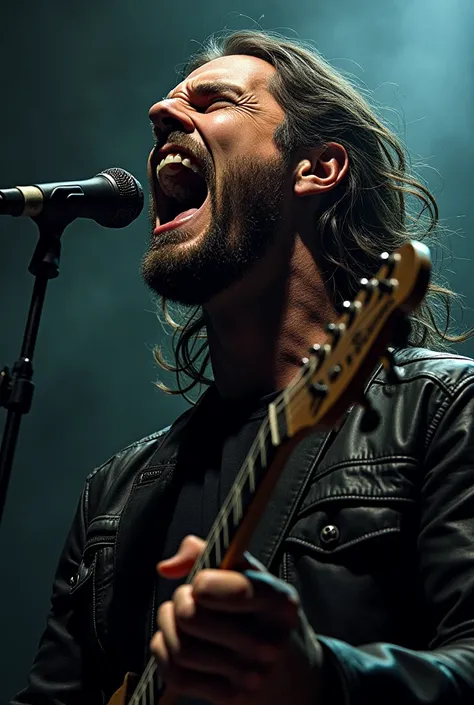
205 237 337 399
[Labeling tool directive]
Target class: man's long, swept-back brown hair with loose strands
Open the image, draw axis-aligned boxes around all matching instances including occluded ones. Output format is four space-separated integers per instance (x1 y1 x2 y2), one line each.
154 30 472 401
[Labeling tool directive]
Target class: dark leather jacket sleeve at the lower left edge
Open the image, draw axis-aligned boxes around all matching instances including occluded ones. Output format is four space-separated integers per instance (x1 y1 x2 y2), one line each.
10 484 103 705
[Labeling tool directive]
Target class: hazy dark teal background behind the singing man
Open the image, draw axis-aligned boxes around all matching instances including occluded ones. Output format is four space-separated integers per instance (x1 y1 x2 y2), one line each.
0 0 474 702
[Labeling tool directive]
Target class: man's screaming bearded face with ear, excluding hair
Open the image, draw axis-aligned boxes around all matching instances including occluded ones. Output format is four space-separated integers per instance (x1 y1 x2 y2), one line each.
143 54 347 304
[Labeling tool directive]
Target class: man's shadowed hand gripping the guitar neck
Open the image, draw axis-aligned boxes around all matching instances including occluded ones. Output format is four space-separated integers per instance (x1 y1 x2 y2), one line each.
151 536 320 705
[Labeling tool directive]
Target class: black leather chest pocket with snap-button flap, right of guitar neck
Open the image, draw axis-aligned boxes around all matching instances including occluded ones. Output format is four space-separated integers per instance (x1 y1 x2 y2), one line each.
282 463 418 644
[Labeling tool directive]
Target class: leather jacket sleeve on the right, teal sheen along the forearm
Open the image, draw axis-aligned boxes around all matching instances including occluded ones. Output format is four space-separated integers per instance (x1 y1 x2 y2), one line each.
317 376 474 705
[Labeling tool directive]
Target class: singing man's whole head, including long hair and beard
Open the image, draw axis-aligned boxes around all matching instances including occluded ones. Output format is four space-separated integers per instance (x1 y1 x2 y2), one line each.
143 31 437 396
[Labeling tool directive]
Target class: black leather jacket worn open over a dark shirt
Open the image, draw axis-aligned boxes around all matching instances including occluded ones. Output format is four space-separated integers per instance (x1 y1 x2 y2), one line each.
11 349 474 705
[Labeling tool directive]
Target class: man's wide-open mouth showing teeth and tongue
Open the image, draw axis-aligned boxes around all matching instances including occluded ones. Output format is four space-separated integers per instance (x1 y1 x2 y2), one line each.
153 149 208 235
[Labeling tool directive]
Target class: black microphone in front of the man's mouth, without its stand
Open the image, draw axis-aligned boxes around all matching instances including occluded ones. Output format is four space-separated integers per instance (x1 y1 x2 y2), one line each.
0 167 143 228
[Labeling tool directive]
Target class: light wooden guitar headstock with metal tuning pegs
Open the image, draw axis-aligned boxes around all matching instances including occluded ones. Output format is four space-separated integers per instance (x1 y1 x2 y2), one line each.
283 241 431 436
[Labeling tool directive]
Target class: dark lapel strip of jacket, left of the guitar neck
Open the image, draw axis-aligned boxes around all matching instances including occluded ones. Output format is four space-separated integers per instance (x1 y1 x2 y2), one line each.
109 388 215 674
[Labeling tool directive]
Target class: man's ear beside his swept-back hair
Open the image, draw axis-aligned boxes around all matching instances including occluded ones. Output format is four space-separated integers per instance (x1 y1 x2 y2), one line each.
294 142 349 196
